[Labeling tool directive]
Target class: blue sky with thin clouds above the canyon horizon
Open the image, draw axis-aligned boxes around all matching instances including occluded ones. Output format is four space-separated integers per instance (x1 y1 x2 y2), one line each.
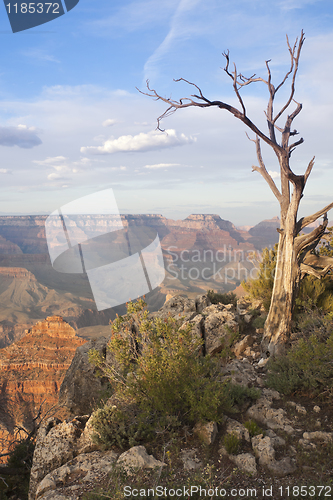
0 0 333 226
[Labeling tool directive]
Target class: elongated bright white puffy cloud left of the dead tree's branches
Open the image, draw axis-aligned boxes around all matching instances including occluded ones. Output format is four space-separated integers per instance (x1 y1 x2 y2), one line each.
80 129 196 154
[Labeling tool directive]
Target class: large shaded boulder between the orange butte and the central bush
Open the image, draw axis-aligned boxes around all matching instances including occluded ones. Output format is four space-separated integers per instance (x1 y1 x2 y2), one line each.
59 337 108 415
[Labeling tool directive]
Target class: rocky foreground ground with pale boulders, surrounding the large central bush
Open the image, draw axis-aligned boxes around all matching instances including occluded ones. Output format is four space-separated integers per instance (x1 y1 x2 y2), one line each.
22 296 333 500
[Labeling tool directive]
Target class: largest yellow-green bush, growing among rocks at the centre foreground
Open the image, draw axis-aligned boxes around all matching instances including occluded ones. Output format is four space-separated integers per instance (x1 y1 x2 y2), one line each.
89 299 230 442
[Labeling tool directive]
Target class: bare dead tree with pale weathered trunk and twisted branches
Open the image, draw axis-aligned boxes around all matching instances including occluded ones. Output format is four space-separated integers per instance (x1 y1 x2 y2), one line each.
142 31 333 355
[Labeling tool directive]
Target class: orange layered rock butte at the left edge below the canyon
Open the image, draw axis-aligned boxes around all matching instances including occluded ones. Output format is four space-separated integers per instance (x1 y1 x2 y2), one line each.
0 316 86 460
